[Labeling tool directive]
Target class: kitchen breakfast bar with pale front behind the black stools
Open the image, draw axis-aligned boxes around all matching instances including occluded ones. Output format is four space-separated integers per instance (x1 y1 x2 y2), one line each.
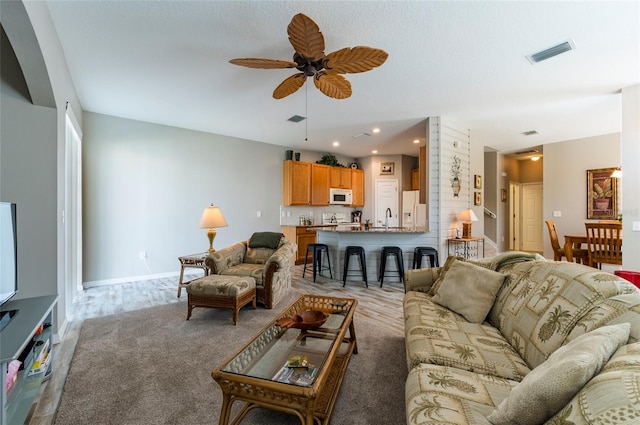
314 225 432 284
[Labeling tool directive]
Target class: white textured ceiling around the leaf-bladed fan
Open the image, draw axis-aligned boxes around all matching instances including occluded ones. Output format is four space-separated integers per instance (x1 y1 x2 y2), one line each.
47 0 640 157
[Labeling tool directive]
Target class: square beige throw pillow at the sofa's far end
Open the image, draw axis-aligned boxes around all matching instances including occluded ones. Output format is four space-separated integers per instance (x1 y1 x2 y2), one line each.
431 259 506 323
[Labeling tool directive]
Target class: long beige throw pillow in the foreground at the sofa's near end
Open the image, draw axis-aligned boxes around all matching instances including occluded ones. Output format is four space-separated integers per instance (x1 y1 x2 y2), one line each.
487 323 631 425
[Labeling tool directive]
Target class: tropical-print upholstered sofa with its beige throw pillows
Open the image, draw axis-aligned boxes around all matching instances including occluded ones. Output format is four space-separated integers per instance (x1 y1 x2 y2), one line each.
404 252 640 425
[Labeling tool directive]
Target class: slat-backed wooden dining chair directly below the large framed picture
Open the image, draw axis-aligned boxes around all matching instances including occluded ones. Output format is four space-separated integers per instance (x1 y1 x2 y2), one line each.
584 223 622 269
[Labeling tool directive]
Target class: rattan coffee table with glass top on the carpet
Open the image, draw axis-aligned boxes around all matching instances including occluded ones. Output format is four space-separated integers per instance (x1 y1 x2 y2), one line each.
211 295 358 425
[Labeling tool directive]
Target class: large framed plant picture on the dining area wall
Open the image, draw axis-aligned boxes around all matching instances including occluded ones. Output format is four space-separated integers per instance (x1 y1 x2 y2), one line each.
587 168 618 220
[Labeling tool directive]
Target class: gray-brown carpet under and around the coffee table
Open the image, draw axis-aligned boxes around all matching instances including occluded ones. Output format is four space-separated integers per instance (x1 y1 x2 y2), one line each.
54 290 407 425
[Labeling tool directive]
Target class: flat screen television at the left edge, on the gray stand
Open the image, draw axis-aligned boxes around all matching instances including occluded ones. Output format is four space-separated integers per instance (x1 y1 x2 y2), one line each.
0 202 18 330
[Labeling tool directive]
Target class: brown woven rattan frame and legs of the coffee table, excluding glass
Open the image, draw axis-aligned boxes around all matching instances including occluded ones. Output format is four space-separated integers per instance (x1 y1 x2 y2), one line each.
211 295 358 425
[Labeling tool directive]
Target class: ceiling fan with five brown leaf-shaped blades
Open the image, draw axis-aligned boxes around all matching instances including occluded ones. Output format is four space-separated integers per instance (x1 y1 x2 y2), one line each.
229 13 389 99
